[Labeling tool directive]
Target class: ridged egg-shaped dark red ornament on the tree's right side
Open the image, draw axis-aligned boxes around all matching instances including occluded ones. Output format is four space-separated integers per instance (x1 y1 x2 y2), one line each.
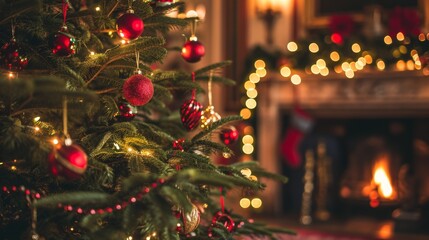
180 98 203 131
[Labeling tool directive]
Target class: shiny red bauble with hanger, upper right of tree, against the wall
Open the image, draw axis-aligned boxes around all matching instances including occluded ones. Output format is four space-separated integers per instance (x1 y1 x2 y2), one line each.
181 20 205 63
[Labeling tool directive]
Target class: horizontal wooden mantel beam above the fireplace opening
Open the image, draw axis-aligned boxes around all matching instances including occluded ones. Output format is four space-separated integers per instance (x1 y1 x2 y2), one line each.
258 71 429 115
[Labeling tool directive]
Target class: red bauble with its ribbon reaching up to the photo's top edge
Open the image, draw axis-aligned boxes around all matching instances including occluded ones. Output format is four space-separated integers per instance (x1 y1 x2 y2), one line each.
50 0 76 57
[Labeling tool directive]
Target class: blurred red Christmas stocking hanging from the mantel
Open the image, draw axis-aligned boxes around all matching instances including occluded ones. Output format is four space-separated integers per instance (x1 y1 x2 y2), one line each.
280 107 313 168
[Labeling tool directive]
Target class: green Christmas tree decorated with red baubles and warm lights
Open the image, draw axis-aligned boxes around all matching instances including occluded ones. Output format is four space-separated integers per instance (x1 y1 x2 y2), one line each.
0 0 289 240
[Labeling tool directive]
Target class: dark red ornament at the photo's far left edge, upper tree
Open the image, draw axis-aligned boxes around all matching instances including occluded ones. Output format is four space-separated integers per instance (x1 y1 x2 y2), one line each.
0 38 28 71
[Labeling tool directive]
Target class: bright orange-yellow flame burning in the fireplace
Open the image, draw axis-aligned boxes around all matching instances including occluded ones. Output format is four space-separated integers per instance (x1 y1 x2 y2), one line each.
373 157 394 198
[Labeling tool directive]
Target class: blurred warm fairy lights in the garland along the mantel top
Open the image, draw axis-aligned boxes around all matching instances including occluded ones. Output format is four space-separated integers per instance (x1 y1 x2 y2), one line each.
279 32 429 82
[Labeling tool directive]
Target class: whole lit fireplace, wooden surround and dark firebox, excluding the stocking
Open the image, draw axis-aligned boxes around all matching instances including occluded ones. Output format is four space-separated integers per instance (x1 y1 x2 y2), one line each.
256 71 429 235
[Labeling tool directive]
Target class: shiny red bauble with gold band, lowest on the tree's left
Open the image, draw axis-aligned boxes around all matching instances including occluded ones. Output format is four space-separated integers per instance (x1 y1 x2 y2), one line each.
49 144 88 180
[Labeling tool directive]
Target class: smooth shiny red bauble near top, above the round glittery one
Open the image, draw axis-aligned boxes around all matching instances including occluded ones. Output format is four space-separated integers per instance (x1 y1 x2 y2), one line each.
116 10 144 40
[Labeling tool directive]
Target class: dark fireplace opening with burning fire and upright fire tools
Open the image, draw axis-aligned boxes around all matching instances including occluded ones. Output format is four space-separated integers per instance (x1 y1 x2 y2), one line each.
280 114 429 229
